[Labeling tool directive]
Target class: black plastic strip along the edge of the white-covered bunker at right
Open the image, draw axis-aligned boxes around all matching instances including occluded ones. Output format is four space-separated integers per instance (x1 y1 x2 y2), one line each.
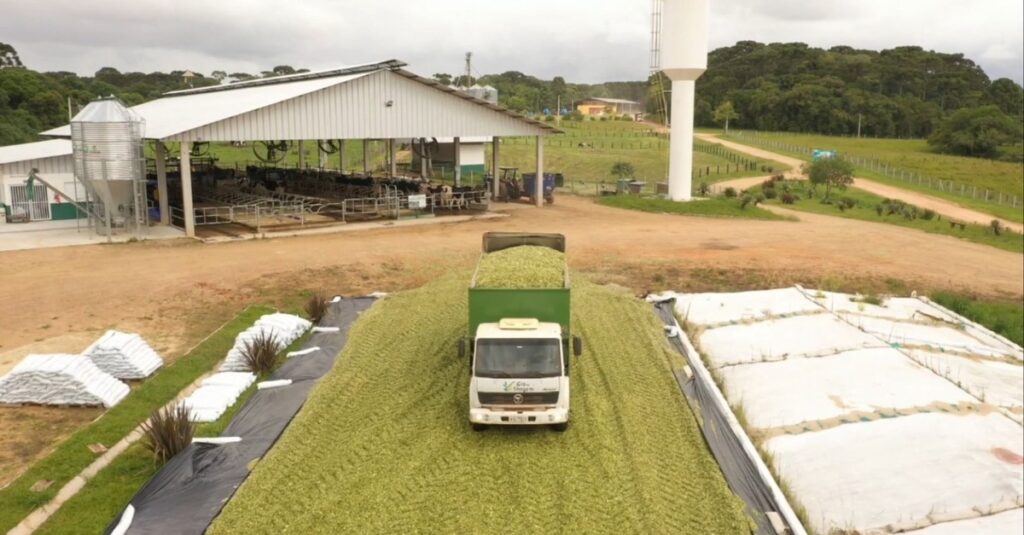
655 299 779 535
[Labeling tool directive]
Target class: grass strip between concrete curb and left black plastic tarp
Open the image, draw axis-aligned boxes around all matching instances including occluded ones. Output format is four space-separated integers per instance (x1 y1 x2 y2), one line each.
36 319 309 535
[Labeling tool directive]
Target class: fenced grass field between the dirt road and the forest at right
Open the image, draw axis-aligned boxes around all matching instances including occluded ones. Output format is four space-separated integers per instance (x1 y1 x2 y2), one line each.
728 132 1024 221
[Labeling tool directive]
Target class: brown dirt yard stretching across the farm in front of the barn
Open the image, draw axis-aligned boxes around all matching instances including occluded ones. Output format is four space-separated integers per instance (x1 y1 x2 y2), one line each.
0 196 1024 486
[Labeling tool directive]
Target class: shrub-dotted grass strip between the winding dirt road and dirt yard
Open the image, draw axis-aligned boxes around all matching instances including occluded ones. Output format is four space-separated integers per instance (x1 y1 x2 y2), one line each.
750 180 1024 252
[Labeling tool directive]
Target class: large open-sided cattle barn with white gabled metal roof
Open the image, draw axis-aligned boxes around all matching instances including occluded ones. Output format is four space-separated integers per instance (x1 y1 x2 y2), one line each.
43 60 560 236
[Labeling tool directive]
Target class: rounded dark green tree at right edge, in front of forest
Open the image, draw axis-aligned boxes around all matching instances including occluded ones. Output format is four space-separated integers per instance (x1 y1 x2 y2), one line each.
928 105 1021 158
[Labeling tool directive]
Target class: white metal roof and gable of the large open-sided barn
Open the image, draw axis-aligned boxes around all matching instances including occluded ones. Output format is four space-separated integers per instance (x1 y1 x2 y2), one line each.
43 59 560 140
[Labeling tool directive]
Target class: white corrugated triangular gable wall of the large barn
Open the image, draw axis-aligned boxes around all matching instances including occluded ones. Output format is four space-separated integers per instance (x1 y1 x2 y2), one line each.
168 71 551 141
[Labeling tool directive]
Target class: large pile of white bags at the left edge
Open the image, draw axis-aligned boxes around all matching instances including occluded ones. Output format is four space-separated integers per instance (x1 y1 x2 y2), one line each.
0 355 131 408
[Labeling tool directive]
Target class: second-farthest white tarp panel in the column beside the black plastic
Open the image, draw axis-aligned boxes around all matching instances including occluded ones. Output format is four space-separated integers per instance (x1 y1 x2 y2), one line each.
698 314 885 367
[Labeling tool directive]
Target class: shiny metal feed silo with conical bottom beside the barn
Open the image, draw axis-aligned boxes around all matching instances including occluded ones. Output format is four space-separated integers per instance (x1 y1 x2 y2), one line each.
71 96 147 237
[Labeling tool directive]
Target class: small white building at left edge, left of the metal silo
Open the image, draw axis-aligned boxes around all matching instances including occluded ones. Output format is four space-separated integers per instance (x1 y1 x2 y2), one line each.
0 139 84 222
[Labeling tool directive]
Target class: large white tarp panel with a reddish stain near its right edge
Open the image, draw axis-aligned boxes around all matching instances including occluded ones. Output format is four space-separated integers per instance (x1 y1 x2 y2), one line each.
765 413 1024 533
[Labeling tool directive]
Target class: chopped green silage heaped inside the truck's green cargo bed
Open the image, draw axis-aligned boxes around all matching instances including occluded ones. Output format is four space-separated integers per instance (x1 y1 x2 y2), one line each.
476 245 565 289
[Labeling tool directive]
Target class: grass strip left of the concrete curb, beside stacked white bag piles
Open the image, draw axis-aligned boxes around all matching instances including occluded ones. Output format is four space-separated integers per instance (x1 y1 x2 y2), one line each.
0 306 273 532
